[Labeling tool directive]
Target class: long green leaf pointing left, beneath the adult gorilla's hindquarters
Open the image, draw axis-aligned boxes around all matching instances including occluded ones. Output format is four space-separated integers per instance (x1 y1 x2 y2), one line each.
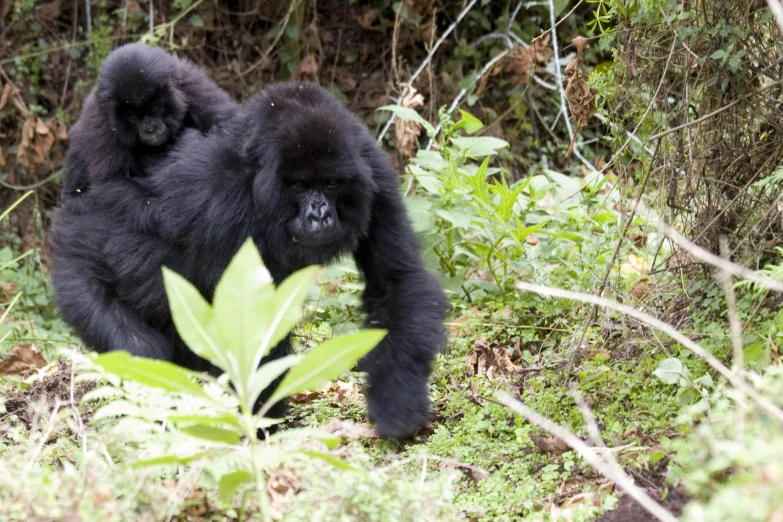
95 351 211 399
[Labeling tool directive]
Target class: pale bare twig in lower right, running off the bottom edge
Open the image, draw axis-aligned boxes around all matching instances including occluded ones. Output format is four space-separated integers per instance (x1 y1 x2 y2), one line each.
498 394 677 522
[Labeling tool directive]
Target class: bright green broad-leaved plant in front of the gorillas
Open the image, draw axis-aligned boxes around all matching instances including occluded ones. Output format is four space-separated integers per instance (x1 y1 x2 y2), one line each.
96 240 385 520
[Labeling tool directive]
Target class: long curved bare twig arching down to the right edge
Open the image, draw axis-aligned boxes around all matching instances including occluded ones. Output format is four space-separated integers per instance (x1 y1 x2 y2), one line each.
514 281 783 423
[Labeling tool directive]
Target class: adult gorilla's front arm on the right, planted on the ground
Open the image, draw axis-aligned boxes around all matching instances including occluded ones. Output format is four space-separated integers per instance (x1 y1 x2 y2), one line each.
355 144 447 438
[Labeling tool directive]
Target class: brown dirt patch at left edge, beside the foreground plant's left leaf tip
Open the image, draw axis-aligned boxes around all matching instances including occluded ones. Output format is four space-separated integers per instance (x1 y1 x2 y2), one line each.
5 361 95 430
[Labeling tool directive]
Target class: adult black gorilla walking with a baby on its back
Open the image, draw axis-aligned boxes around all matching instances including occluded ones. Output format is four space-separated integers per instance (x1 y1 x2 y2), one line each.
52 83 446 438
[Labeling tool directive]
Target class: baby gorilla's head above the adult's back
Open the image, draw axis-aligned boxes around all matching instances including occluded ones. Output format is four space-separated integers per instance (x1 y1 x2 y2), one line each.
96 44 187 148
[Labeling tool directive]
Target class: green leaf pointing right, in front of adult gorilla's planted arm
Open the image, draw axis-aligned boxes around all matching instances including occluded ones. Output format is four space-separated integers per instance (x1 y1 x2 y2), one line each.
267 330 386 404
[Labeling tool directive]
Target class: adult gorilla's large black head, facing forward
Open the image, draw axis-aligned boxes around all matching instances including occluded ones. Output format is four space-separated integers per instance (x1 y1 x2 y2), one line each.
245 83 377 270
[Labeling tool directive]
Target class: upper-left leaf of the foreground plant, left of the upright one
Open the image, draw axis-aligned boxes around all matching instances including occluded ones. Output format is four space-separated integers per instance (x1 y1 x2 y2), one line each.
163 267 230 372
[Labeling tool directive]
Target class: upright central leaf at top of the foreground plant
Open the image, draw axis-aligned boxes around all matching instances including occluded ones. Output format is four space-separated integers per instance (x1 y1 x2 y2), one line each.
213 239 275 390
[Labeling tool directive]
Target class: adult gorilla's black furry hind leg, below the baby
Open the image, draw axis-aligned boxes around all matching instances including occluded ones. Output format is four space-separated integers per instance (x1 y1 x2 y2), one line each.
51 208 174 360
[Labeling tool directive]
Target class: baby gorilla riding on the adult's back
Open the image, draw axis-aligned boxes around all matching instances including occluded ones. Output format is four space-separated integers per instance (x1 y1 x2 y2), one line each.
61 44 238 202
